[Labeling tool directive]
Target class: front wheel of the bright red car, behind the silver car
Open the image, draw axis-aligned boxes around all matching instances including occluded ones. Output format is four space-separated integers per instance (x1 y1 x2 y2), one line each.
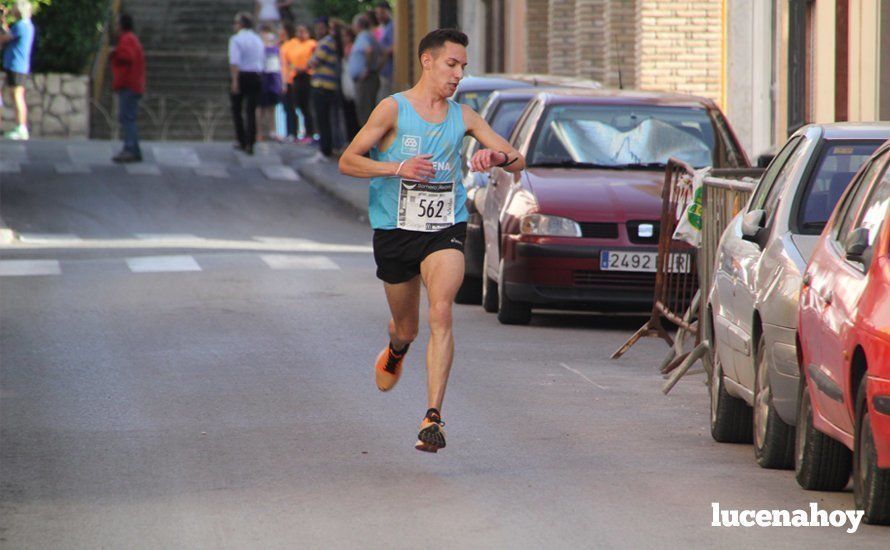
794 373 852 491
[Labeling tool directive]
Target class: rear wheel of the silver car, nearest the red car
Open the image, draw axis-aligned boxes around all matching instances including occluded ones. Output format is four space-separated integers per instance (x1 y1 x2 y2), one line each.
753 336 794 469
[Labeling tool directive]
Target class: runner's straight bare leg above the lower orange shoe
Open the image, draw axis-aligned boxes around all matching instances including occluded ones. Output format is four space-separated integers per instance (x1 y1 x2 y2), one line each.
420 249 464 411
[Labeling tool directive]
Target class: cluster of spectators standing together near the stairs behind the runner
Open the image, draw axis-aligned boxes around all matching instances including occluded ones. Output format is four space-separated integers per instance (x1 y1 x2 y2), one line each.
229 0 394 158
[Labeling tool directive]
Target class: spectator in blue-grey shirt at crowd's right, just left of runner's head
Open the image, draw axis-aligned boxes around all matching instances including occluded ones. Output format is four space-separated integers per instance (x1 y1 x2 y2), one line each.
347 14 380 126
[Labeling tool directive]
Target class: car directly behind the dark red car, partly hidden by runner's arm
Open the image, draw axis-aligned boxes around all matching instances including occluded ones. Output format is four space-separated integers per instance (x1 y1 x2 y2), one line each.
455 88 552 304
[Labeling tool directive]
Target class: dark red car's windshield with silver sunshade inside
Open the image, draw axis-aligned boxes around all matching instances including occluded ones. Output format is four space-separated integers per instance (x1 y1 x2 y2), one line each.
529 105 719 169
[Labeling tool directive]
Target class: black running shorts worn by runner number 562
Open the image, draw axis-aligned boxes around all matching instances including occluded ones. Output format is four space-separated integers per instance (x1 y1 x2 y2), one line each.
374 222 467 284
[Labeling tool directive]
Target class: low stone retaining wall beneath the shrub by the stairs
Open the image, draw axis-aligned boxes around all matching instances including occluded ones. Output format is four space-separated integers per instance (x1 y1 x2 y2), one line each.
2 73 90 138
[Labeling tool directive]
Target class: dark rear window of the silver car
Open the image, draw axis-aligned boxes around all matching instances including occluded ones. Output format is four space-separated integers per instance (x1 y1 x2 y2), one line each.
797 140 882 235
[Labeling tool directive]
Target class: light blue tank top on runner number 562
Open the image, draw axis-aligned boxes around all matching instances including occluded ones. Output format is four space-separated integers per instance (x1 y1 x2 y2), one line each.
368 93 467 229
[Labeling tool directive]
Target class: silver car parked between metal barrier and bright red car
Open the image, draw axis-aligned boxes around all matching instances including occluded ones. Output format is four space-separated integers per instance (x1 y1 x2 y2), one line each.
708 123 890 468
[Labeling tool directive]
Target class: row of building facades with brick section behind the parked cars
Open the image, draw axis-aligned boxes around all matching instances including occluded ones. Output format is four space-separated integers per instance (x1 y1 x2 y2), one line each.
395 0 890 157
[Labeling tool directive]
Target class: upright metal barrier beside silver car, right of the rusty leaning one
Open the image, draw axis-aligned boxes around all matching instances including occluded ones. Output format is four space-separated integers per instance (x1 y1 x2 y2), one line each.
662 168 763 393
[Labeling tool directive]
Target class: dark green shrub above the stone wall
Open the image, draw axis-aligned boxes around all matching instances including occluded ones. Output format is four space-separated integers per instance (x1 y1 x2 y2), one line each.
0 0 110 74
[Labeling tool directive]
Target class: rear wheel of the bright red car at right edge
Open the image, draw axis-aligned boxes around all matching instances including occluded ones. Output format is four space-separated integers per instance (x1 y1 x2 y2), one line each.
853 376 890 525
